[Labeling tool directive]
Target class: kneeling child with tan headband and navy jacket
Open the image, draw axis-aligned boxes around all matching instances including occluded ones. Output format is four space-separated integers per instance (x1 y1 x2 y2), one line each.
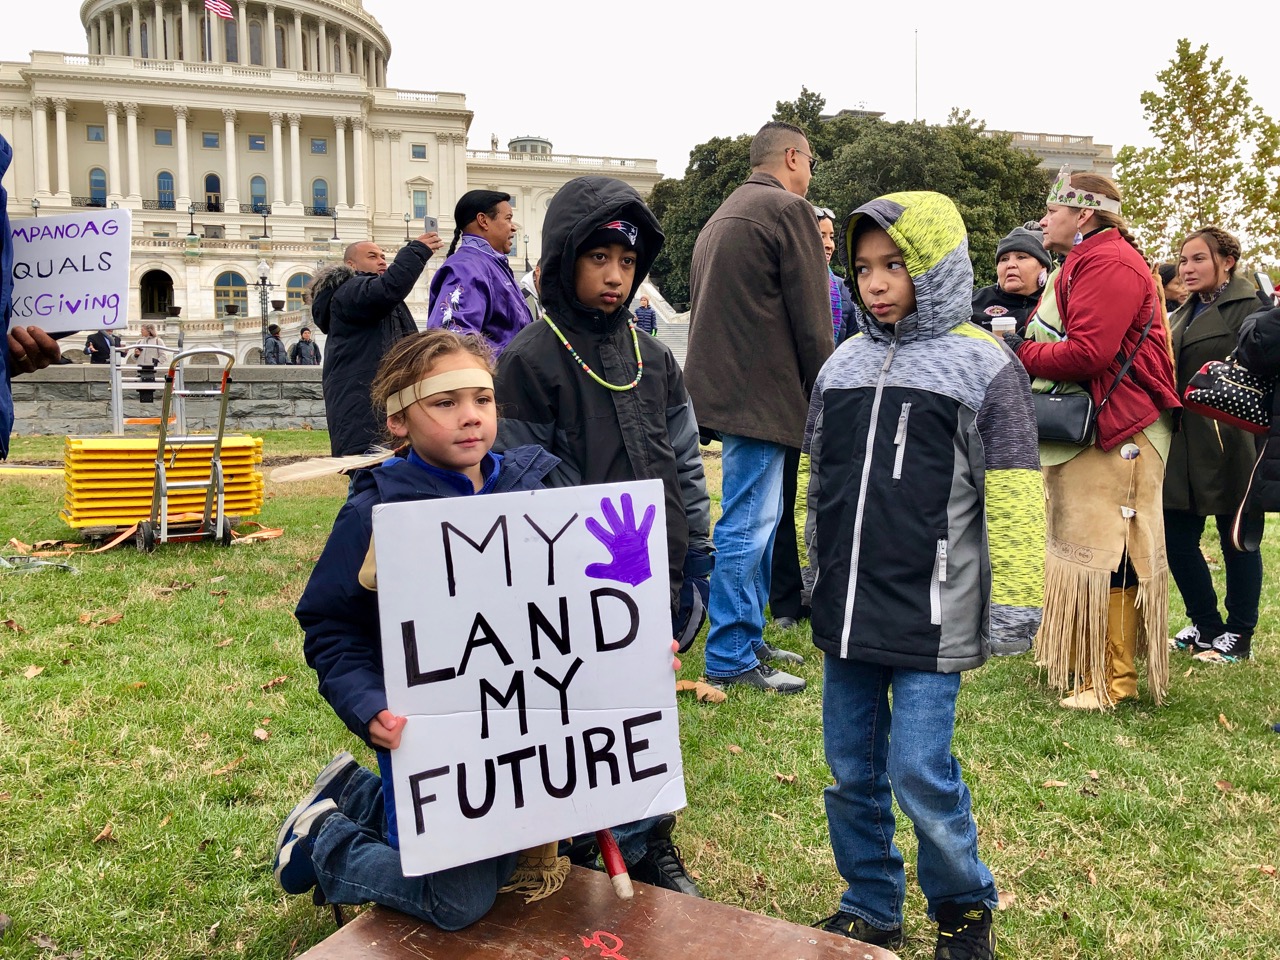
275 330 558 929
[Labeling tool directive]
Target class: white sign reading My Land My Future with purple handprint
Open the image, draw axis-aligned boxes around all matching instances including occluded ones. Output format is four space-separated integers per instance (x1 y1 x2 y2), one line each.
374 480 685 877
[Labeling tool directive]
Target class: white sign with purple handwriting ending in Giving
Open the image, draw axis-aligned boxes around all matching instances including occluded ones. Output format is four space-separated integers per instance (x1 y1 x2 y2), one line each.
10 210 133 333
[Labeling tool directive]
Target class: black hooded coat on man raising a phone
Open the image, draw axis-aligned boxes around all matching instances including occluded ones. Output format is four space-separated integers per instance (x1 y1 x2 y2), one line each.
311 241 431 457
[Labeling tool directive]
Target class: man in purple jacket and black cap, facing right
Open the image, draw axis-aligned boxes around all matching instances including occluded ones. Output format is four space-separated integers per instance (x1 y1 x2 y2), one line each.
426 189 532 358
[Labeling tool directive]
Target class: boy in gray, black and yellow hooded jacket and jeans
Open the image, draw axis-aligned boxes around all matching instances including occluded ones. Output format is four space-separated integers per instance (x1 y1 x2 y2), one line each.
805 192 1044 960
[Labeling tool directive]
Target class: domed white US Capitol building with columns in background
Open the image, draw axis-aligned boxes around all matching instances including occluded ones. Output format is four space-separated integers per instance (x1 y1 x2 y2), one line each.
0 0 660 362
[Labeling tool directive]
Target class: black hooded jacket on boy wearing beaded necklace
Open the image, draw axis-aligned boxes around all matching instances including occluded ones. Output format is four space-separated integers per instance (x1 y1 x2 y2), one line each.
494 177 710 603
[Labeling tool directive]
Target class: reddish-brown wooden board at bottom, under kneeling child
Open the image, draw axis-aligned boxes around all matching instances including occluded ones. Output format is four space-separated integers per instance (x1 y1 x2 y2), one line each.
300 867 896 960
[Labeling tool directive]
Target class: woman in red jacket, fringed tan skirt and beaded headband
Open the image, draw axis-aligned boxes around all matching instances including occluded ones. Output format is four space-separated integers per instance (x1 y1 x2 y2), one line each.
1006 166 1179 709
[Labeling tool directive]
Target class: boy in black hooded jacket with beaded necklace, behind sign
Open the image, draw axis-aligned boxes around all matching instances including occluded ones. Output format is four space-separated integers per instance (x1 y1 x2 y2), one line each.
494 177 713 896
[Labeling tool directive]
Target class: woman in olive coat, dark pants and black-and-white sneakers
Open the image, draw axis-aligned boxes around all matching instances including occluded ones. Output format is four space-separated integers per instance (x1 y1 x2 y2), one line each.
1165 227 1262 662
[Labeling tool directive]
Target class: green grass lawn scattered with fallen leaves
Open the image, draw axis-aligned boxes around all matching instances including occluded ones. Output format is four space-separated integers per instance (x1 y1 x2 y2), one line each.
0 431 1280 960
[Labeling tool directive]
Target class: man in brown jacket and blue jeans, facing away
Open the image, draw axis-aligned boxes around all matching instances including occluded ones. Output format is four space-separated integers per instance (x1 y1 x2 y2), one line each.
685 122 833 694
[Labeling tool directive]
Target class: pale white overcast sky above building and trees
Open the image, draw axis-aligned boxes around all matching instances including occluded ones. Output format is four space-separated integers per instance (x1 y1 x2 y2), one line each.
0 0 1280 177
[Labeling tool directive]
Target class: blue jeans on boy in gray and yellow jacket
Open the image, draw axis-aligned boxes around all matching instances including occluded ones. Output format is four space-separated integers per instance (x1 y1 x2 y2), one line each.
822 657 996 929
